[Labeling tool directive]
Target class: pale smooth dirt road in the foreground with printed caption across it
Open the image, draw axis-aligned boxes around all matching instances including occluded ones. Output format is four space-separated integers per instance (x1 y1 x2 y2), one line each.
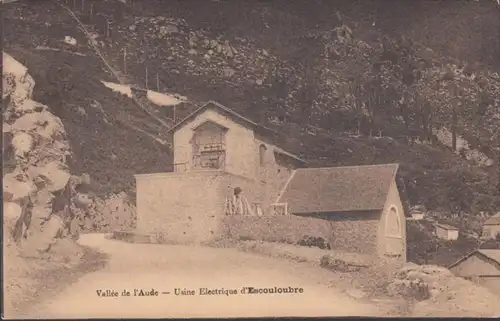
14 234 378 319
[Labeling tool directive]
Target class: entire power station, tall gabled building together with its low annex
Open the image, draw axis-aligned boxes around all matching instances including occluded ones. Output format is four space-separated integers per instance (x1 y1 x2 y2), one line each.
136 102 406 258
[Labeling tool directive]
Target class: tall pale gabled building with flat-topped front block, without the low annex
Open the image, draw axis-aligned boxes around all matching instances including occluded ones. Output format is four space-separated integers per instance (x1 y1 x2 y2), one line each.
136 102 306 243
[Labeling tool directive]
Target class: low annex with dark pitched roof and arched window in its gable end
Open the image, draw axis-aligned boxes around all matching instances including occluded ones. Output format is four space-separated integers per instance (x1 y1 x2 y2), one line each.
278 164 406 260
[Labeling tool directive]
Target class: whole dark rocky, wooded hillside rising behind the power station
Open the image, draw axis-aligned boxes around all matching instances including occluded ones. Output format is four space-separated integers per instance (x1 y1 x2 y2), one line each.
3 0 500 218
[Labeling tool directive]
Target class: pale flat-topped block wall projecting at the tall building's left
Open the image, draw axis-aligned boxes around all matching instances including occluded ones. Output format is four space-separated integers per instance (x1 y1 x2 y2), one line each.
136 171 225 244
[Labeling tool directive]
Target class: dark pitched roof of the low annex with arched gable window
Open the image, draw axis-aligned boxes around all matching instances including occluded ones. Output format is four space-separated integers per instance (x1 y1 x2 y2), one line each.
279 164 399 214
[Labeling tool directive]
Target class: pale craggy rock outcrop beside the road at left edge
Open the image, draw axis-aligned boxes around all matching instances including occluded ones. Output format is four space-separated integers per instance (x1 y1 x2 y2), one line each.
2 53 88 254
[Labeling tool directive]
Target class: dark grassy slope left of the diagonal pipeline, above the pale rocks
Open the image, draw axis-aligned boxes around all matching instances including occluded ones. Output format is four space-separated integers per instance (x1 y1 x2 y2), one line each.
3 1 171 195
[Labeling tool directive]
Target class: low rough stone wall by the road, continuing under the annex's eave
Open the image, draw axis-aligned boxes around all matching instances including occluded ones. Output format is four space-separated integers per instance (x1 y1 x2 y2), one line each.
220 213 378 254
